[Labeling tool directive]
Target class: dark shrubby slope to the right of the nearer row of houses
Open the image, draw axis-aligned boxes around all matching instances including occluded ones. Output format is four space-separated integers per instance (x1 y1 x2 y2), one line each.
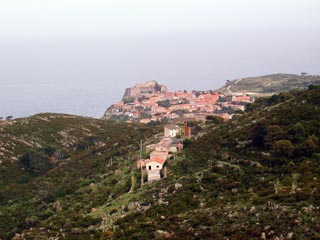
108 85 320 239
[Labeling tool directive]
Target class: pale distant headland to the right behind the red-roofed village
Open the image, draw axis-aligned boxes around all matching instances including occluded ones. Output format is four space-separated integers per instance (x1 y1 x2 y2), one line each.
219 73 320 95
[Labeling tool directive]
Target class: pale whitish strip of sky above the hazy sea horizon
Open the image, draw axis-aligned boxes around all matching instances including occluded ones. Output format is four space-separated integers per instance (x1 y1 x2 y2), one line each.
0 0 320 40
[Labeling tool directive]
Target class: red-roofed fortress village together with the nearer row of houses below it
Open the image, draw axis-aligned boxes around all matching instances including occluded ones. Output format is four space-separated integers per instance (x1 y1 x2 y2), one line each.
104 80 253 184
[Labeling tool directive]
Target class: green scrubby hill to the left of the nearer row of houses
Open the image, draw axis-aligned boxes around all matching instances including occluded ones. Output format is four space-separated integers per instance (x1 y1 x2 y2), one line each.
0 114 158 239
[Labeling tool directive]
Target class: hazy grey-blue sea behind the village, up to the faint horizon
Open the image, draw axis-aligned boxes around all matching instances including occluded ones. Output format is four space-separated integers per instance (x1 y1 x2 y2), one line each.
0 29 320 118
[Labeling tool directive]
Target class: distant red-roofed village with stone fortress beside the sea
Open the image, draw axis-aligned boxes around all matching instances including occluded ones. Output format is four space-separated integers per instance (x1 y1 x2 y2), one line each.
104 80 253 123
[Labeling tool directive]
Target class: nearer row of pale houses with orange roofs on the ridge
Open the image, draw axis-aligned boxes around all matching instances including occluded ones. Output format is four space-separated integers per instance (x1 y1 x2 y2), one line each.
137 125 186 182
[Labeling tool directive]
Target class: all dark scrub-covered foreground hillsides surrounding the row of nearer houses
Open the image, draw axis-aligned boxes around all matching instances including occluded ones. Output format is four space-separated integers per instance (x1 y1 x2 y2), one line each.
0 86 320 239
